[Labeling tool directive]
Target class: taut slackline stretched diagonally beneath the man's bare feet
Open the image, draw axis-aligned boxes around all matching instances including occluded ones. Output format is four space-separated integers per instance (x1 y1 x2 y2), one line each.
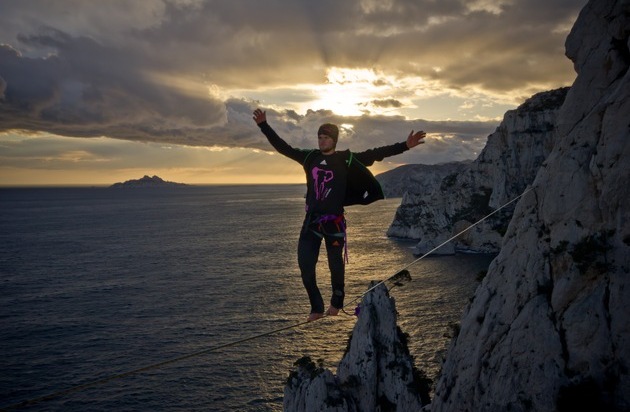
0 187 533 411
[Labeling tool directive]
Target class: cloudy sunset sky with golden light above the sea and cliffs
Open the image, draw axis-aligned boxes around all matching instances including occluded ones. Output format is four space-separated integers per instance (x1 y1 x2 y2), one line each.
0 0 586 186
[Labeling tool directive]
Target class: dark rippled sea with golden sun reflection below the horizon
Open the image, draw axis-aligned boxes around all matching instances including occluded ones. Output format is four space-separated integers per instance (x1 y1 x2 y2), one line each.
0 185 493 412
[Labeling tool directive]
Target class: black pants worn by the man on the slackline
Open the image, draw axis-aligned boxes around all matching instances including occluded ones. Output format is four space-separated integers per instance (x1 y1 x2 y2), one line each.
298 221 345 313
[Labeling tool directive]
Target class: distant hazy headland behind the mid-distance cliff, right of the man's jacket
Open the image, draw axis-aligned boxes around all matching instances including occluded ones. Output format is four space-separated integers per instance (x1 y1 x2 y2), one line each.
376 160 472 197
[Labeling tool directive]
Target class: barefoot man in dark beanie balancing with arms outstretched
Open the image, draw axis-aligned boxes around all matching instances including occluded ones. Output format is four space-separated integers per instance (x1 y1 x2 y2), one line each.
253 109 426 321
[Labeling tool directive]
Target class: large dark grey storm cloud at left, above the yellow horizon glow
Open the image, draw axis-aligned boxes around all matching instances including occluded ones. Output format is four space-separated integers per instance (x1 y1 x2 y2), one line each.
0 29 225 140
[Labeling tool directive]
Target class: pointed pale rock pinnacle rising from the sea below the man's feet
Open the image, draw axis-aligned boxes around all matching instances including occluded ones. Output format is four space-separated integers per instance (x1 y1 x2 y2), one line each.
284 284 429 412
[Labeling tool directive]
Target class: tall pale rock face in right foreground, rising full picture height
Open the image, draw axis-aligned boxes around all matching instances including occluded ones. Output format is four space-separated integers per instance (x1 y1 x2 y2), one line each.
431 0 630 412
